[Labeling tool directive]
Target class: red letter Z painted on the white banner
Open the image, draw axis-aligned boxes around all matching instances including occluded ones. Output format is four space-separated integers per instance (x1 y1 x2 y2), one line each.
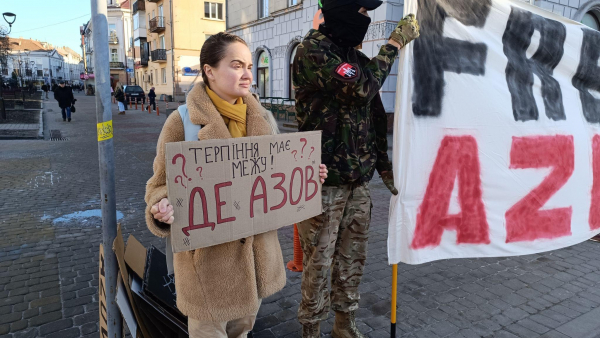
505 135 575 243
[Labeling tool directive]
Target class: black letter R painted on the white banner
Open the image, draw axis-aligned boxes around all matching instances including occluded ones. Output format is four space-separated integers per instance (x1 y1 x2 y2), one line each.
502 7 567 121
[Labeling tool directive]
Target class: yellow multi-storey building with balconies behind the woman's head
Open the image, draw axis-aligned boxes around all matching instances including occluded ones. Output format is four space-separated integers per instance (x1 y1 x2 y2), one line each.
132 0 226 101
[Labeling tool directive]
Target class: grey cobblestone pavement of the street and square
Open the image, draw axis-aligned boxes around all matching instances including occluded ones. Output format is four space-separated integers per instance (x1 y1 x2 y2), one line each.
0 94 600 338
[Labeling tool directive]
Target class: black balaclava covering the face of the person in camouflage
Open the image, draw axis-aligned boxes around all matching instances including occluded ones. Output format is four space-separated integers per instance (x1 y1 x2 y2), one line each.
319 3 371 47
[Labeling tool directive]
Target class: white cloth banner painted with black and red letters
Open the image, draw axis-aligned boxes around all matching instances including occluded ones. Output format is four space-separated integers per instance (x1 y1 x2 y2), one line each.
388 0 600 264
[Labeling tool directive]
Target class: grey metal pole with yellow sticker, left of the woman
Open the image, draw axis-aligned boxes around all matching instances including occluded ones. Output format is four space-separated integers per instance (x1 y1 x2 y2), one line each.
90 0 123 338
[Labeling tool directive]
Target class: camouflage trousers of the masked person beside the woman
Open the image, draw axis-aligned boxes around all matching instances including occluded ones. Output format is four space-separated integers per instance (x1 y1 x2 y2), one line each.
297 183 372 324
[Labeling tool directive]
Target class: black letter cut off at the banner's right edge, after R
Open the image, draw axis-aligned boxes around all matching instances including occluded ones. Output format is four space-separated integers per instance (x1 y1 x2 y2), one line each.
573 28 600 123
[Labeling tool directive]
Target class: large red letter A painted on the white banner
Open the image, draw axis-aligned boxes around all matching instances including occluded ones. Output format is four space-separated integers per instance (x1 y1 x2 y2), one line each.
411 136 490 249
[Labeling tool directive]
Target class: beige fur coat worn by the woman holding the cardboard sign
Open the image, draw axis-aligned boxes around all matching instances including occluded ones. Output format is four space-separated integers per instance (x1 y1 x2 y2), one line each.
145 84 286 322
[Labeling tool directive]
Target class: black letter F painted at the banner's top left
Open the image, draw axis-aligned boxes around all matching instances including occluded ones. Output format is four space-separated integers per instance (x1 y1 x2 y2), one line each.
413 0 492 116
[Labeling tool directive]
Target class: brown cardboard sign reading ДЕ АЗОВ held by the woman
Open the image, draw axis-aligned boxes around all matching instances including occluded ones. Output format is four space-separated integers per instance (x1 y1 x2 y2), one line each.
166 131 322 252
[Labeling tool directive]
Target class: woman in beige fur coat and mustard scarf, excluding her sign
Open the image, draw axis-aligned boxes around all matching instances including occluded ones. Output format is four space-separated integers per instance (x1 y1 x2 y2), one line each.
145 33 327 338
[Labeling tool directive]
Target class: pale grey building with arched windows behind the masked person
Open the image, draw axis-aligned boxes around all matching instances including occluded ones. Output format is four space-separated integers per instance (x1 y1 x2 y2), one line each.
227 0 600 114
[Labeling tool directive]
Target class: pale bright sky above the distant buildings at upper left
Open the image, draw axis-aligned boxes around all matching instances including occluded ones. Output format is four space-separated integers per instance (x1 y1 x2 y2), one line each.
0 0 91 55
